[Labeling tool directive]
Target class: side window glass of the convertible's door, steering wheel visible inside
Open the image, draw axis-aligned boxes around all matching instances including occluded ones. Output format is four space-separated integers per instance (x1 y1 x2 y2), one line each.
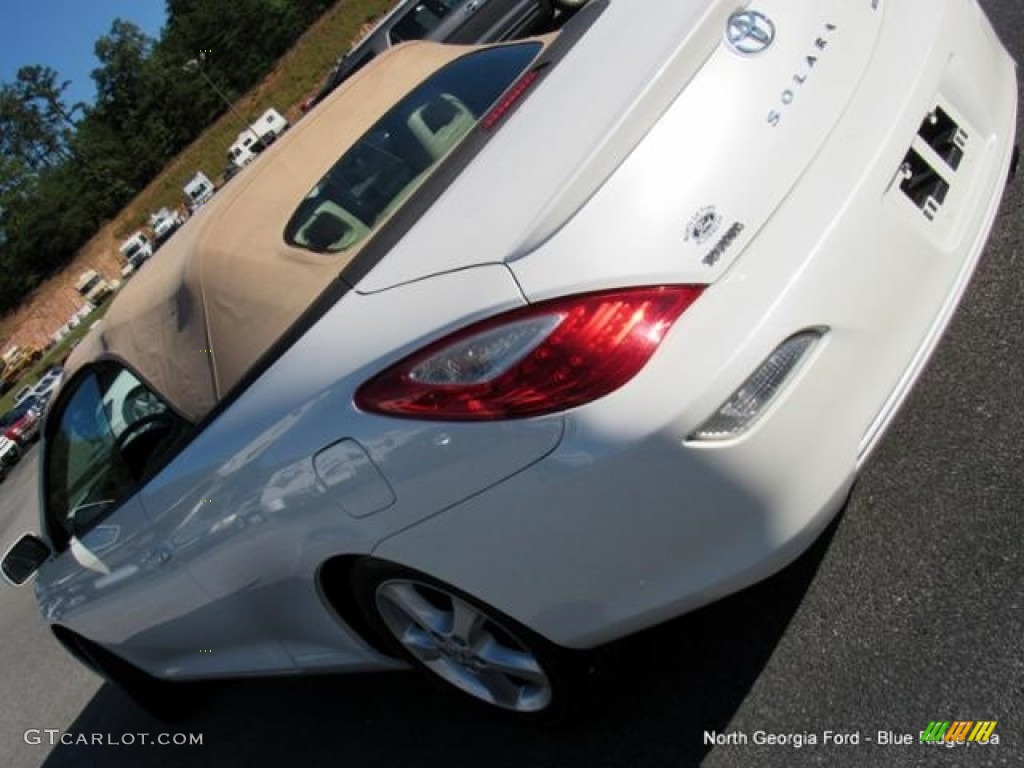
44 366 186 546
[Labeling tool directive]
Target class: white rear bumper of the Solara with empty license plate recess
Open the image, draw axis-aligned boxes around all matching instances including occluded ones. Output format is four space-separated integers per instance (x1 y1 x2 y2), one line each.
375 1 1017 647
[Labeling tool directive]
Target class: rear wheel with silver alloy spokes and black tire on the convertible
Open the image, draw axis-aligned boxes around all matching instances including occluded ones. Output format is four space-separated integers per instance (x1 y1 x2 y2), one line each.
352 560 597 726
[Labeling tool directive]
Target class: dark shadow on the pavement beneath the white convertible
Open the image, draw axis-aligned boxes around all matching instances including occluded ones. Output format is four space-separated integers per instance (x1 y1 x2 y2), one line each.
37 517 842 768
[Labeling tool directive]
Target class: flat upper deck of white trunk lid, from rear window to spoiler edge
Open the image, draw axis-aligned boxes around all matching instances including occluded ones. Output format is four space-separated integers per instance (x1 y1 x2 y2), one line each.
358 0 735 292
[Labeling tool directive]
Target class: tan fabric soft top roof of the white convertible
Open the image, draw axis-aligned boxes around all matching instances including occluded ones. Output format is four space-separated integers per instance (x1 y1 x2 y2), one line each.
68 42 470 421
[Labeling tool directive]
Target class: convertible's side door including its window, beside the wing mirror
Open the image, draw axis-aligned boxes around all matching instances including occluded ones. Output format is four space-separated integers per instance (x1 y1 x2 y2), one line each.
36 362 202 674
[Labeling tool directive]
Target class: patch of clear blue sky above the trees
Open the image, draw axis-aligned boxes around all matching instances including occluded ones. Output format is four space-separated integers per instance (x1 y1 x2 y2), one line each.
0 0 167 105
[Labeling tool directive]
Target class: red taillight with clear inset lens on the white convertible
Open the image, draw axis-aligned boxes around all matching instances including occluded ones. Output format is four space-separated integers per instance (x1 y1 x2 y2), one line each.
355 286 703 421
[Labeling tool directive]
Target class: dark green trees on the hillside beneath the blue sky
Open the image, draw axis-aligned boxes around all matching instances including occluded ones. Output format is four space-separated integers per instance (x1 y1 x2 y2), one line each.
0 0 333 311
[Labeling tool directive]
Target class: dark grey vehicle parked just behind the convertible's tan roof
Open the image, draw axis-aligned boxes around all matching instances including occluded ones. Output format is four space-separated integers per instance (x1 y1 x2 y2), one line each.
302 0 584 112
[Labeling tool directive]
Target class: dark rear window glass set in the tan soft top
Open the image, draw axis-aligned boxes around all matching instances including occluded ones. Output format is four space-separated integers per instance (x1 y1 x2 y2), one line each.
285 43 541 253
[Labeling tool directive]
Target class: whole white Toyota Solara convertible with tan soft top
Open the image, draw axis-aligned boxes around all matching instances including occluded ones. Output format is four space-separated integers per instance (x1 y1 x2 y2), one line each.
3 0 1017 720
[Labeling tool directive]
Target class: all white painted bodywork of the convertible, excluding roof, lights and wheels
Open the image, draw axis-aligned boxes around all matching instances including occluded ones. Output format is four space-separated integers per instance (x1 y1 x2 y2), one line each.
19 0 1017 678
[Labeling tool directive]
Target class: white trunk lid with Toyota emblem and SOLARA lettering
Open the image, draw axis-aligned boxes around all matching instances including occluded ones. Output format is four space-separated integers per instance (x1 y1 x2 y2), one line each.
357 0 882 300
